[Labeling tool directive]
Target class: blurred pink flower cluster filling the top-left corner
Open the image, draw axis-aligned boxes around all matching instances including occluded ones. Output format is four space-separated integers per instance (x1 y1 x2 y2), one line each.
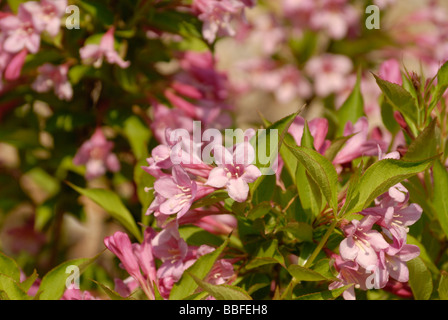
0 0 67 89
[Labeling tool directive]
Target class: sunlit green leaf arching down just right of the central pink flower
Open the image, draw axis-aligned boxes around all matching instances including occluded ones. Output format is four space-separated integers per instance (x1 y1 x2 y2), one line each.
287 145 338 212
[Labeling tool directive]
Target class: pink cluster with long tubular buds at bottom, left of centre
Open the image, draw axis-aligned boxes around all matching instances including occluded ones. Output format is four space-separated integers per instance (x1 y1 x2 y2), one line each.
104 222 234 300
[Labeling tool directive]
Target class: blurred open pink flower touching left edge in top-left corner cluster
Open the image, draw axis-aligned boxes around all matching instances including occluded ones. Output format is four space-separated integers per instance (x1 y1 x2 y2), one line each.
0 4 40 53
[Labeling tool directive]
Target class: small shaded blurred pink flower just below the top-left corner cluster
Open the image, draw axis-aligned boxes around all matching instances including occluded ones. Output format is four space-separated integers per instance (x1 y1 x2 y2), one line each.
32 63 73 100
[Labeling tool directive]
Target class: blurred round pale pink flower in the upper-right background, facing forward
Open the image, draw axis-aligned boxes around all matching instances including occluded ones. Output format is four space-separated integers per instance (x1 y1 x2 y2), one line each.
305 53 353 97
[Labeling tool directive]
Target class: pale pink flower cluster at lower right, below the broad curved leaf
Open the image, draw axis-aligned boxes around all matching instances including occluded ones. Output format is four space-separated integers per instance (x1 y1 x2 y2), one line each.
329 152 422 299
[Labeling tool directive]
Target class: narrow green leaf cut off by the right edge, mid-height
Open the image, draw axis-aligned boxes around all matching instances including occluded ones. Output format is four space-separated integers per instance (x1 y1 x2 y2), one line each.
432 160 448 236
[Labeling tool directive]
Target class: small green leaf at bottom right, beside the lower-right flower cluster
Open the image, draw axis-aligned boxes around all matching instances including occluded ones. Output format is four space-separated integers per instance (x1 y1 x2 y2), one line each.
407 257 433 300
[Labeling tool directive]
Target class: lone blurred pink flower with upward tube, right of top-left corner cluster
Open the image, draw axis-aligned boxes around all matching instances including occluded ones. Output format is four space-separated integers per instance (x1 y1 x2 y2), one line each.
79 28 131 69
